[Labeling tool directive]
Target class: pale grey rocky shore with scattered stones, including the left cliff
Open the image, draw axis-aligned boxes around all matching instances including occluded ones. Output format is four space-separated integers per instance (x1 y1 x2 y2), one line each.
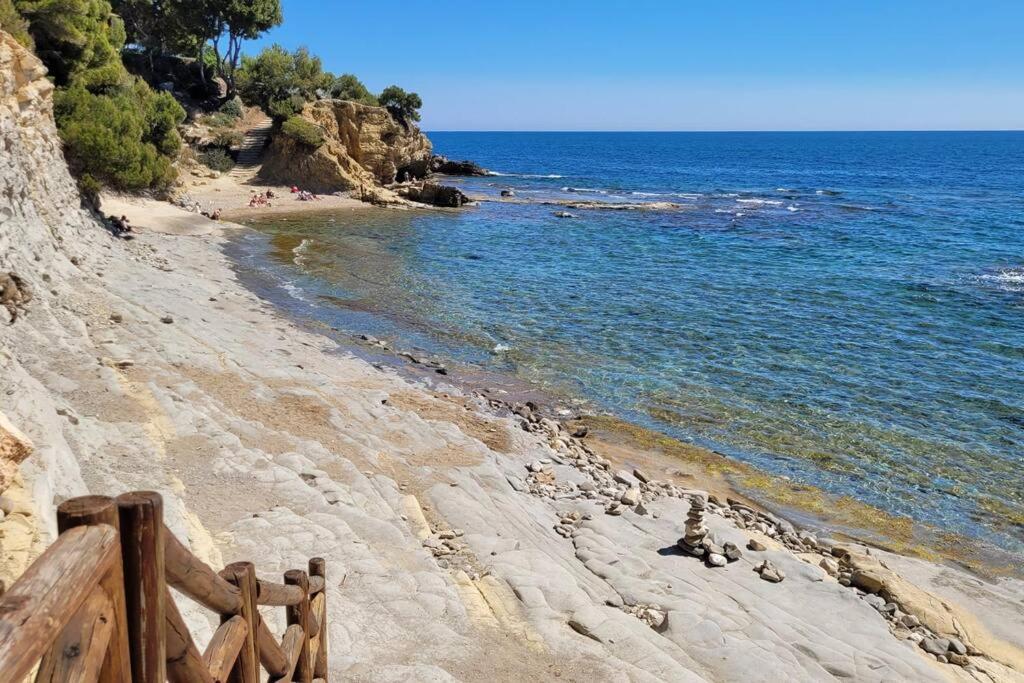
6 26 1024 683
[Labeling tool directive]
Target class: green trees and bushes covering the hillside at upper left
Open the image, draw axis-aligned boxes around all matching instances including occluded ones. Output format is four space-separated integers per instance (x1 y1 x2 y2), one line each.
0 0 423 195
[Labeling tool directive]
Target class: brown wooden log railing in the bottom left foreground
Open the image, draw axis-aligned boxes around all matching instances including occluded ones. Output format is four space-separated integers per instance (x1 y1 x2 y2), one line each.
0 492 328 683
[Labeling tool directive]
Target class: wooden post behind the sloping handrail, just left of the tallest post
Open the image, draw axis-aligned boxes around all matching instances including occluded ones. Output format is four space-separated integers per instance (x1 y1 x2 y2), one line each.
57 496 131 683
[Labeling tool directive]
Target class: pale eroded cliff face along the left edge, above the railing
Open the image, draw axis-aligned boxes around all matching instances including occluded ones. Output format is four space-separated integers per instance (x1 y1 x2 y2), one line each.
0 31 105 585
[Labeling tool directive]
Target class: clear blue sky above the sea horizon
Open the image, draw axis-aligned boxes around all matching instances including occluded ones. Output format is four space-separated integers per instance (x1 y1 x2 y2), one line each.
248 0 1024 130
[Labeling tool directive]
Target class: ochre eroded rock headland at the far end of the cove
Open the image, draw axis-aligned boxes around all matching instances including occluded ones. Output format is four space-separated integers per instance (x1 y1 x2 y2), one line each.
261 99 431 200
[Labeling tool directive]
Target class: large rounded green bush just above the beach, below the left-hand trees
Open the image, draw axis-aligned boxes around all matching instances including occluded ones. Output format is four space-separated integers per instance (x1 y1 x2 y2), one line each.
53 82 184 189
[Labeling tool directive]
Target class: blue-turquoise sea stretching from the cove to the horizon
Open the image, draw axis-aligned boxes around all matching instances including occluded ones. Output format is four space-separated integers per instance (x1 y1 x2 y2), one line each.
231 133 1024 553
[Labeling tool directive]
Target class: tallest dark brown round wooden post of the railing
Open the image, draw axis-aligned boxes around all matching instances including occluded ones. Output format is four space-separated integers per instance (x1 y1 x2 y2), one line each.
117 490 167 683
